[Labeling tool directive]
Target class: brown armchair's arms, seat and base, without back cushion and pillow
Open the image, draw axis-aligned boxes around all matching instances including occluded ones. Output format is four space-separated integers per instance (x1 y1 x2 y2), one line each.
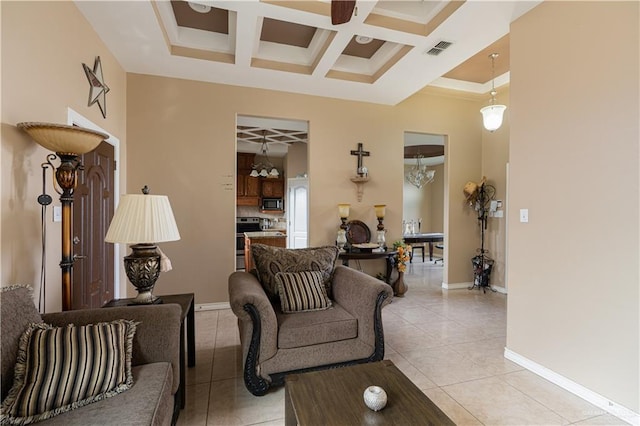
229 249 393 396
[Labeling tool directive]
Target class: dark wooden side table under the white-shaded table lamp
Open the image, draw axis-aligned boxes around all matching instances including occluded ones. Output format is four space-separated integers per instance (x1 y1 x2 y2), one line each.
102 293 196 408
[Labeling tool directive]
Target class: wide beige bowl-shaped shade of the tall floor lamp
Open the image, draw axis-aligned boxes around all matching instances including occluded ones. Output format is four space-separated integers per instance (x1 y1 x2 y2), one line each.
17 122 109 155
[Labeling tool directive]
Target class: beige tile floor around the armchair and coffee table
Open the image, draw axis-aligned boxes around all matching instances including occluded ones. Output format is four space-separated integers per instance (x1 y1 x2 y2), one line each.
178 259 626 426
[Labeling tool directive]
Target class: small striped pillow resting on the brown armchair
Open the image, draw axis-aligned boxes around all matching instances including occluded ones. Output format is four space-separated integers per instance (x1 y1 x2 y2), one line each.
276 271 331 313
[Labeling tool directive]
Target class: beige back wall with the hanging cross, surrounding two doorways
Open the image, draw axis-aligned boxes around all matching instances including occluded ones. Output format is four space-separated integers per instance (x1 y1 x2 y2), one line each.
127 74 481 303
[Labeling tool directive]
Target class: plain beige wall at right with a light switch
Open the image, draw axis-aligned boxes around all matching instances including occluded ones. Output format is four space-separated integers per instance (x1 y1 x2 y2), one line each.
507 2 640 413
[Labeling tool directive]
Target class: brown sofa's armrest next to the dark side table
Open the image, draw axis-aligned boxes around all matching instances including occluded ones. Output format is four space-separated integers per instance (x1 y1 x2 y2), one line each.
42 303 182 393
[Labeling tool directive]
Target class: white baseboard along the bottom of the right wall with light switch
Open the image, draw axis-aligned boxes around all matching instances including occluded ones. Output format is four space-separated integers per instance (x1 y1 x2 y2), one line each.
504 348 640 426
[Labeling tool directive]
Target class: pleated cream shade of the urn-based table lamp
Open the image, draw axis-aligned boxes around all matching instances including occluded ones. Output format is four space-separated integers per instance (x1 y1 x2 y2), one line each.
104 194 180 244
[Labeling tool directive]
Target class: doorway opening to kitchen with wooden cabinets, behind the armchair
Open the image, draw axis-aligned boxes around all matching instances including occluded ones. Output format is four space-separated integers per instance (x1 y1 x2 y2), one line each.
236 115 309 270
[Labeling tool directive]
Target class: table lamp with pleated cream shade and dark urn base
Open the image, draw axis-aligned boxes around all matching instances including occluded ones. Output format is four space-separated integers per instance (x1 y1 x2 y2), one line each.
104 186 180 305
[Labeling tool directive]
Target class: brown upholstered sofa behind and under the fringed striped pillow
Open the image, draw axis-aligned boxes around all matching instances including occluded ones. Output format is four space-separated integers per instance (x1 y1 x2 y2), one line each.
0 286 181 425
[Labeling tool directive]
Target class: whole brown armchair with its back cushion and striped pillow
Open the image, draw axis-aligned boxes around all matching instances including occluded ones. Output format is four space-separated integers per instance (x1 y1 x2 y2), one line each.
229 244 393 396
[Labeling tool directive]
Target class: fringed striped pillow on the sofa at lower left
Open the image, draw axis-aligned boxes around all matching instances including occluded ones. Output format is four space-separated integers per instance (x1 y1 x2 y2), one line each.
0 320 138 424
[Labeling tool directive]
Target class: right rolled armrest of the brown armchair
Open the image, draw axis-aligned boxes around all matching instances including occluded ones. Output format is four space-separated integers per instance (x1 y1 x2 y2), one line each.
332 265 393 345
